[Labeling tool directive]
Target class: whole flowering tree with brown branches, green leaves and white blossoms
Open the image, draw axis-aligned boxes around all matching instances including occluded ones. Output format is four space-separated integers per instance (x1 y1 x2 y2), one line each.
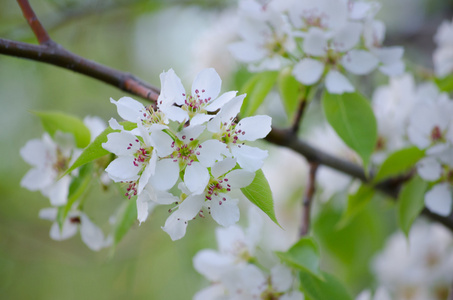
0 0 453 300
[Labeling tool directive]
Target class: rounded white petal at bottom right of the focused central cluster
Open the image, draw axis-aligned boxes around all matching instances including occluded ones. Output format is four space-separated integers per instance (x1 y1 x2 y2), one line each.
211 194 240 227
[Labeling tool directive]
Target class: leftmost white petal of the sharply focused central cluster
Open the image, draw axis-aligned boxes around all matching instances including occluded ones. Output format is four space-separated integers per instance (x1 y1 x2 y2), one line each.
102 132 140 156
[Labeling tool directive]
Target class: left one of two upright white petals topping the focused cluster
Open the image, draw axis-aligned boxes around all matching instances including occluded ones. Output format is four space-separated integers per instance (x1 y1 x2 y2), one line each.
157 69 186 107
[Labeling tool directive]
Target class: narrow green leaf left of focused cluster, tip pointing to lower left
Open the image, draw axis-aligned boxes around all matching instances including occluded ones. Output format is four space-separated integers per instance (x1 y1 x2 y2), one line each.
62 122 137 176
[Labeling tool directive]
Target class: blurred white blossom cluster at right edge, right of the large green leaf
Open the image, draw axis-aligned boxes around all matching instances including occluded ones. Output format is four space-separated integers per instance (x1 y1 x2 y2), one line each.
373 74 453 216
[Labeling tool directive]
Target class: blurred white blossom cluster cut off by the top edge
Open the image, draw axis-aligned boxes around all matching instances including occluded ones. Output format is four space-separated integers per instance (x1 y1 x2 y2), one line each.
230 0 404 94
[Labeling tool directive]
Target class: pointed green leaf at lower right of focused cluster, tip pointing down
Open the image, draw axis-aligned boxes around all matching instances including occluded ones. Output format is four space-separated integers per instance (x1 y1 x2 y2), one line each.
241 169 280 226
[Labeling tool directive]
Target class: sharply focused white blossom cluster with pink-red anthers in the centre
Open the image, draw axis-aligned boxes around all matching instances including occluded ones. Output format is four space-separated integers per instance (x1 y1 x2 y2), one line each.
103 69 271 240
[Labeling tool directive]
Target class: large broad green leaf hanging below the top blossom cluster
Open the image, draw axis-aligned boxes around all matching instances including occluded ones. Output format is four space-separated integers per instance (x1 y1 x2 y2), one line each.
322 91 377 166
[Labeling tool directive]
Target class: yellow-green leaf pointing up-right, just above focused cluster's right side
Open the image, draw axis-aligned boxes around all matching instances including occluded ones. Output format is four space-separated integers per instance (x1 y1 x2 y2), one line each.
241 71 278 118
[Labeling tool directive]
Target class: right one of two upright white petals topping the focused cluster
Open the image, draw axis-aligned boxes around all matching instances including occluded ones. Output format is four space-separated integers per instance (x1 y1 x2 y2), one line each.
192 68 222 101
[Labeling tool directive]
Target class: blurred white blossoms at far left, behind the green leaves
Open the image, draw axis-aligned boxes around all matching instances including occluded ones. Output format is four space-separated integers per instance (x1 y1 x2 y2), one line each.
20 117 112 251
